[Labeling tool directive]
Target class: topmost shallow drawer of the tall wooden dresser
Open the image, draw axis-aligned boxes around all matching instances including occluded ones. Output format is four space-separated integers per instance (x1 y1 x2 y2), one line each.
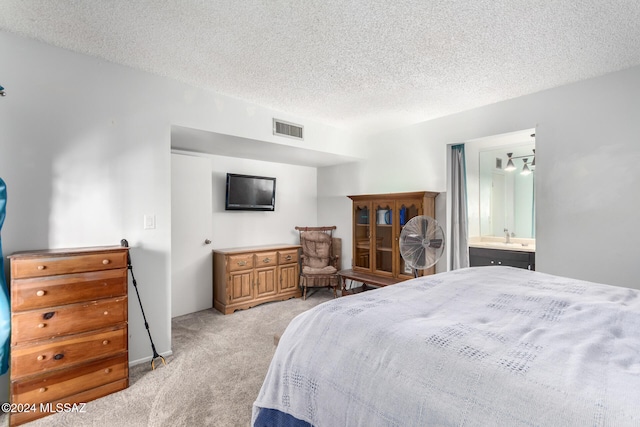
11 251 127 279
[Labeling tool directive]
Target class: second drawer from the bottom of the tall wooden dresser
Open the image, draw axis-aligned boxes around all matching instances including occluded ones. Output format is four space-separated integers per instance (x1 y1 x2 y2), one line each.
11 325 127 379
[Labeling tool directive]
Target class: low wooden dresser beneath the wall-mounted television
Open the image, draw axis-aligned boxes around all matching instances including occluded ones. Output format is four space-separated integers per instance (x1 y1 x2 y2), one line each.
213 245 302 314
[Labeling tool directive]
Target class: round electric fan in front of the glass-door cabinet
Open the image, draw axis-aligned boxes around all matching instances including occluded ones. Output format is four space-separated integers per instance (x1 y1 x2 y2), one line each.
400 215 444 277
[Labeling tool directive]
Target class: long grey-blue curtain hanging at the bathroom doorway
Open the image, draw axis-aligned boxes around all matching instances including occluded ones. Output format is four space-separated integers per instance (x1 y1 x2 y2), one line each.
449 144 469 270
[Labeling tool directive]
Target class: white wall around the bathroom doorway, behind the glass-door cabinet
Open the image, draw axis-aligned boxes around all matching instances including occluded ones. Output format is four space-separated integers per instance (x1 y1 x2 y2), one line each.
318 67 640 289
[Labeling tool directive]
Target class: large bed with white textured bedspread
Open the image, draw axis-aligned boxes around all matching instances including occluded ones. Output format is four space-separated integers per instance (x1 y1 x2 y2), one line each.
252 267 640 427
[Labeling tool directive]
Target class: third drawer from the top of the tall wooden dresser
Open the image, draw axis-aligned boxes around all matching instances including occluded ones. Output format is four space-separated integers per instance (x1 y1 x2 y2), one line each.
11 297 127 345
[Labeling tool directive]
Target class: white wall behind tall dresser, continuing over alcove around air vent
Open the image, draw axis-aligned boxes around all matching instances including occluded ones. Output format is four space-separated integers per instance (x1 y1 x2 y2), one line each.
0 32 353 401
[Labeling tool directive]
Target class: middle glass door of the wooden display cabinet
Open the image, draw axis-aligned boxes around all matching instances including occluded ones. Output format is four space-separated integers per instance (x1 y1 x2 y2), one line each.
371 200 397 276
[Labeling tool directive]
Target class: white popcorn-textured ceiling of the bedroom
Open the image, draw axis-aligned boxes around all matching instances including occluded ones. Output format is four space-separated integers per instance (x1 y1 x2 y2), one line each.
0 0 640 131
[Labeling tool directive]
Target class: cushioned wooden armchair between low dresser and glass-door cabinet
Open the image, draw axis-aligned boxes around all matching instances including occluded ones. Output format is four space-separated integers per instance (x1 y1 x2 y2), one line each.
296 225 340 299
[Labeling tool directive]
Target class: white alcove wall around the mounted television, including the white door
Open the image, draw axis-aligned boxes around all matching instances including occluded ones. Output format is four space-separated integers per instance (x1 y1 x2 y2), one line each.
171 151 317 317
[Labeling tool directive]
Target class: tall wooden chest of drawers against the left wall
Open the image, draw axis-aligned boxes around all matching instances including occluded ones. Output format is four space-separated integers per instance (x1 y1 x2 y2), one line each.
9 246 129 426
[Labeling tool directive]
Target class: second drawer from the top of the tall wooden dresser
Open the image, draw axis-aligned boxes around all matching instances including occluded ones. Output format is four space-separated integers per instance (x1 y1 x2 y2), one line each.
11 269 128 311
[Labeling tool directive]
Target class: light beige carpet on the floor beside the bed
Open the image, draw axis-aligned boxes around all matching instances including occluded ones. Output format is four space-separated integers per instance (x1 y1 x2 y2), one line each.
5 289 333 427
